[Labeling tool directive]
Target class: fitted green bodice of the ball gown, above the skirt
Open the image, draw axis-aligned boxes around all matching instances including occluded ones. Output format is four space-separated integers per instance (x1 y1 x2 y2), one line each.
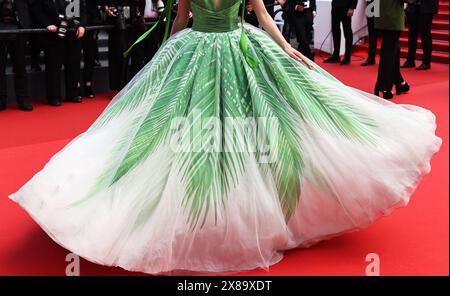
191 0 242 32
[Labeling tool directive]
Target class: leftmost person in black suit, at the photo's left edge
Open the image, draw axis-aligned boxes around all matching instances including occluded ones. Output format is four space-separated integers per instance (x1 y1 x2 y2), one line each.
0 0 33 111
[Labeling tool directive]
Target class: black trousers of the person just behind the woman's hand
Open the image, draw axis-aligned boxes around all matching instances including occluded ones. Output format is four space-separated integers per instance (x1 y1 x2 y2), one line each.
290 9 314 59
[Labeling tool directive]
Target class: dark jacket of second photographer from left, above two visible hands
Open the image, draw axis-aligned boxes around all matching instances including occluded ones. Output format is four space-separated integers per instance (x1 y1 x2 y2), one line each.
29 0 89 28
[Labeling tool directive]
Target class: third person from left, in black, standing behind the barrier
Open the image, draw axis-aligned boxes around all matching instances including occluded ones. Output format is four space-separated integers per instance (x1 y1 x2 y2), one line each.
82 0 103 99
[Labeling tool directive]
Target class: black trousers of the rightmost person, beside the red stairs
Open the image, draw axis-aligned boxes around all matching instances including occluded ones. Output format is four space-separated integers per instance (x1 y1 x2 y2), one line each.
406 5 433 64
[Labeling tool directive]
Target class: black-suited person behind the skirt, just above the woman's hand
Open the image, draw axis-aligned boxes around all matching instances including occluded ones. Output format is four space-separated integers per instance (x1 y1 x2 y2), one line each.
287 0 316 60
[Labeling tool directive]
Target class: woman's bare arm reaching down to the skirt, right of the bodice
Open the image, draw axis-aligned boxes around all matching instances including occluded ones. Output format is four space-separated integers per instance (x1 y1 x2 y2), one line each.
250 0 311 69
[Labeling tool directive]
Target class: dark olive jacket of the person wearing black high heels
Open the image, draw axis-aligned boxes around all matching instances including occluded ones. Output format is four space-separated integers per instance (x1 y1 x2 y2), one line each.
375 0 405 31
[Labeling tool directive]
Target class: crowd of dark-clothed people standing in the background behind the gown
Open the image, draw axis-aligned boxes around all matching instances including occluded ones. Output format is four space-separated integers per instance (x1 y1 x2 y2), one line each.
0 0 438 111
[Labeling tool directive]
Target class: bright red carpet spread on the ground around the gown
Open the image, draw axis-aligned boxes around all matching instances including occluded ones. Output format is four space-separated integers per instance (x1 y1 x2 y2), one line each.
0 58 449 275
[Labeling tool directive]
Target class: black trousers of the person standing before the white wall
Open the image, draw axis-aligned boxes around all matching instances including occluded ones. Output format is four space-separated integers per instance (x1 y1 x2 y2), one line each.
331 6 353 59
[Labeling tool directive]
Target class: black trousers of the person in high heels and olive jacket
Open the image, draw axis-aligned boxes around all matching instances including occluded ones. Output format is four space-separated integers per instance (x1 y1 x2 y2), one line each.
375 30 404 91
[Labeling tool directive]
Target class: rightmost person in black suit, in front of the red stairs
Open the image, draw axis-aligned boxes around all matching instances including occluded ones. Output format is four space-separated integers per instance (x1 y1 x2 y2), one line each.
402 0 439 70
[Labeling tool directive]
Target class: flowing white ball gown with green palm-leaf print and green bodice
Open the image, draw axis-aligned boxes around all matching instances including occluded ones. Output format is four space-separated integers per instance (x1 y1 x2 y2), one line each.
11 0 441 274
